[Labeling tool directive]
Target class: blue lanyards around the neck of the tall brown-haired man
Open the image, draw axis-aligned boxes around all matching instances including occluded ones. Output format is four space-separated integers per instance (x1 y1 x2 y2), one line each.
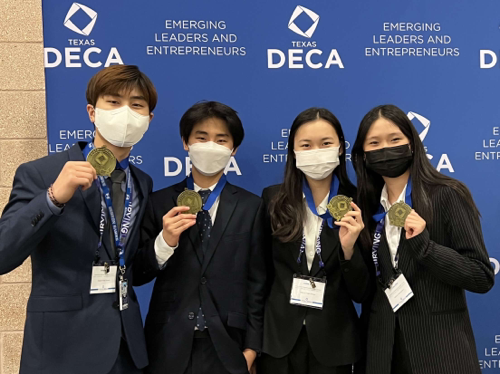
83 142 133 274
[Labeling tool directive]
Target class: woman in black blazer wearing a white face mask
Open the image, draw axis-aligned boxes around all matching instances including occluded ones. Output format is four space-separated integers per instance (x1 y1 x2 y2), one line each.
259 108 369 374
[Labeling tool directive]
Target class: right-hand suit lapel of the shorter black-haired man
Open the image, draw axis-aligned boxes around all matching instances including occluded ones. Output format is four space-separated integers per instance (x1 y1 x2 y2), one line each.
198 183 238 274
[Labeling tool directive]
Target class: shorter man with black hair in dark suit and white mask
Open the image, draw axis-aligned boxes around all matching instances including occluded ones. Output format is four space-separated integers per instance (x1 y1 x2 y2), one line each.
135 101 266 374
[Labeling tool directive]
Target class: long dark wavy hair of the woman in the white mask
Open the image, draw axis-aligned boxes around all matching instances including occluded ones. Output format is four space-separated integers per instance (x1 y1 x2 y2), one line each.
269 108 356 243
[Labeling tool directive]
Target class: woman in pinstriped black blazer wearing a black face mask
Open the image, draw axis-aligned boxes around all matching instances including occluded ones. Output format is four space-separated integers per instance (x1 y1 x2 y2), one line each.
352 105 494 374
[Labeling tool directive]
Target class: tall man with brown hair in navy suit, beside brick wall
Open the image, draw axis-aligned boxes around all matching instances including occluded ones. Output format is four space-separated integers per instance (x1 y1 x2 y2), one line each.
0 65 157 374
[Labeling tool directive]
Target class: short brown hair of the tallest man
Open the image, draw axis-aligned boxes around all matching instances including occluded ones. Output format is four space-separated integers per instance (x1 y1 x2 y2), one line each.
86 65 158 112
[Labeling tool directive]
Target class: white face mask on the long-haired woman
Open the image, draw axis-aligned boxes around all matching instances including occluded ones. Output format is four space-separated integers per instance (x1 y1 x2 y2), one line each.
294 147 340 180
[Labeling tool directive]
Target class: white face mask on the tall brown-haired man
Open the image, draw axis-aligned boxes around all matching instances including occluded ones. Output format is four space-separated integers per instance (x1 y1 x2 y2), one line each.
95 105 149 147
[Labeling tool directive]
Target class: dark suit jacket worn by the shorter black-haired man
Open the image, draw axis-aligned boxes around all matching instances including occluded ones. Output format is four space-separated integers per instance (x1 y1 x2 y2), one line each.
135 180 266 374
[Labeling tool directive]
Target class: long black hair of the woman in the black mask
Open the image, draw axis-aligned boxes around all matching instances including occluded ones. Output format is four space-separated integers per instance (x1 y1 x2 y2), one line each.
352 105 479 250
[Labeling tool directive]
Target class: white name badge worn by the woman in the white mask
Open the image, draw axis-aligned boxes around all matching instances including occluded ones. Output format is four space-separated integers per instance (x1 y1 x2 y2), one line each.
290 274 326 309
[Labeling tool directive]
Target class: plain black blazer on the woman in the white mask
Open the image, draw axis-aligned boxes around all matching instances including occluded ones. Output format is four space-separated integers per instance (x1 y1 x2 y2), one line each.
262 185 370 366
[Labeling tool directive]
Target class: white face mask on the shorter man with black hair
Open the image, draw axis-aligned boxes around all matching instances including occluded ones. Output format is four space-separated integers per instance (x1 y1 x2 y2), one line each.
188 142 233 176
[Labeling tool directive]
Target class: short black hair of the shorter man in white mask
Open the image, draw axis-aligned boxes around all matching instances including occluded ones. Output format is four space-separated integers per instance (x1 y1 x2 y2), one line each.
180 101 245 148
